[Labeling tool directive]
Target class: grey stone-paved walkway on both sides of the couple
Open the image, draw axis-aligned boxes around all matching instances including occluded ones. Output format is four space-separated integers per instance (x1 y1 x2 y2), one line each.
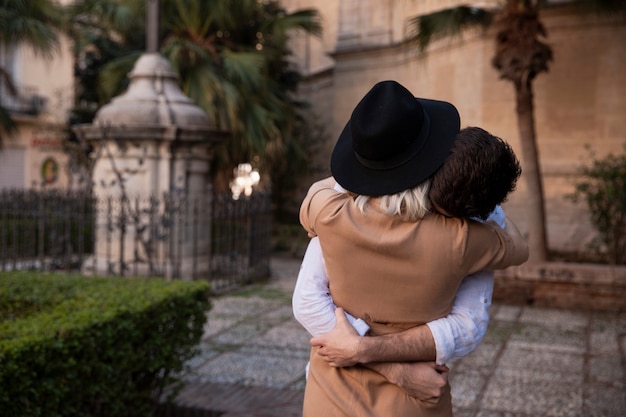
165 257 626 417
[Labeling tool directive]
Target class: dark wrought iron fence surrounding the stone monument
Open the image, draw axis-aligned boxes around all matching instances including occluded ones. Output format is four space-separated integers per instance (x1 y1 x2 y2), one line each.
0 190 271 292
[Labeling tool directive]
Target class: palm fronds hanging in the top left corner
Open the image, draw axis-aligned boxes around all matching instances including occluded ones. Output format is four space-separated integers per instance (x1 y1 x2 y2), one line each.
0 0 63 145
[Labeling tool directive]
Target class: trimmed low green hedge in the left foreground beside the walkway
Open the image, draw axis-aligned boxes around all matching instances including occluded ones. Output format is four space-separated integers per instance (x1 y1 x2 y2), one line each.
0 272 210 417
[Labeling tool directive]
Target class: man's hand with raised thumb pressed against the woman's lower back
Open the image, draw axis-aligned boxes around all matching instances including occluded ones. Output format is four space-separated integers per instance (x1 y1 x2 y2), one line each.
310 307 361 368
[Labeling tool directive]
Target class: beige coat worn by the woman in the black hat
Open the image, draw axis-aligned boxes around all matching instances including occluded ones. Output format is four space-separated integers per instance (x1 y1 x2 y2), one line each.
300 179 524 417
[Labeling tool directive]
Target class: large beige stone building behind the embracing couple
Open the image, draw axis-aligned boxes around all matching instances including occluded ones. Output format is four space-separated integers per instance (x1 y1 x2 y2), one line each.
285 0 626 251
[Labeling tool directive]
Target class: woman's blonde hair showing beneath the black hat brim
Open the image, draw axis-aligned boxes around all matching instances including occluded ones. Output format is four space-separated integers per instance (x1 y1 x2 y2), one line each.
355 180 431 221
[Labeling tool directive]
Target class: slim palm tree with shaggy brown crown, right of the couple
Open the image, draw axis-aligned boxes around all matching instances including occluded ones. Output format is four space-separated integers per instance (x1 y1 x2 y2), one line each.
406 0 625 262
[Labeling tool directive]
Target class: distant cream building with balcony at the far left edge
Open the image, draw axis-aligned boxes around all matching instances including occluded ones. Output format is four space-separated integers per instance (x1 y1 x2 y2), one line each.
0 1 74 189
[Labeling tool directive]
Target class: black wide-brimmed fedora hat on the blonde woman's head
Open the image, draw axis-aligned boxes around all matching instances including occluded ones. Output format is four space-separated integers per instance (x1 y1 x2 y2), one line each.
330 81 461 196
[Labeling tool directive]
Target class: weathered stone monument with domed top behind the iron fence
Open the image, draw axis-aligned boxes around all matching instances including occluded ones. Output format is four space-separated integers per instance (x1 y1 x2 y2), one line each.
74 53 226 278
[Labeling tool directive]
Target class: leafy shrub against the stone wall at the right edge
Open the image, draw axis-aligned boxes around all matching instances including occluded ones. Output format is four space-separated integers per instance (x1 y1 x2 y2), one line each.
569 147 626 264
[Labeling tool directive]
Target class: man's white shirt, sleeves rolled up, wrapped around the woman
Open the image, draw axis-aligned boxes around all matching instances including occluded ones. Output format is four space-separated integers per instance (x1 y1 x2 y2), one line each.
292 206 505 364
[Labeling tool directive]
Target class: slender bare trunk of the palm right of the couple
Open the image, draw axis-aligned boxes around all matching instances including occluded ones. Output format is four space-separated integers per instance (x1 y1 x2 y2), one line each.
515 80 548 262
